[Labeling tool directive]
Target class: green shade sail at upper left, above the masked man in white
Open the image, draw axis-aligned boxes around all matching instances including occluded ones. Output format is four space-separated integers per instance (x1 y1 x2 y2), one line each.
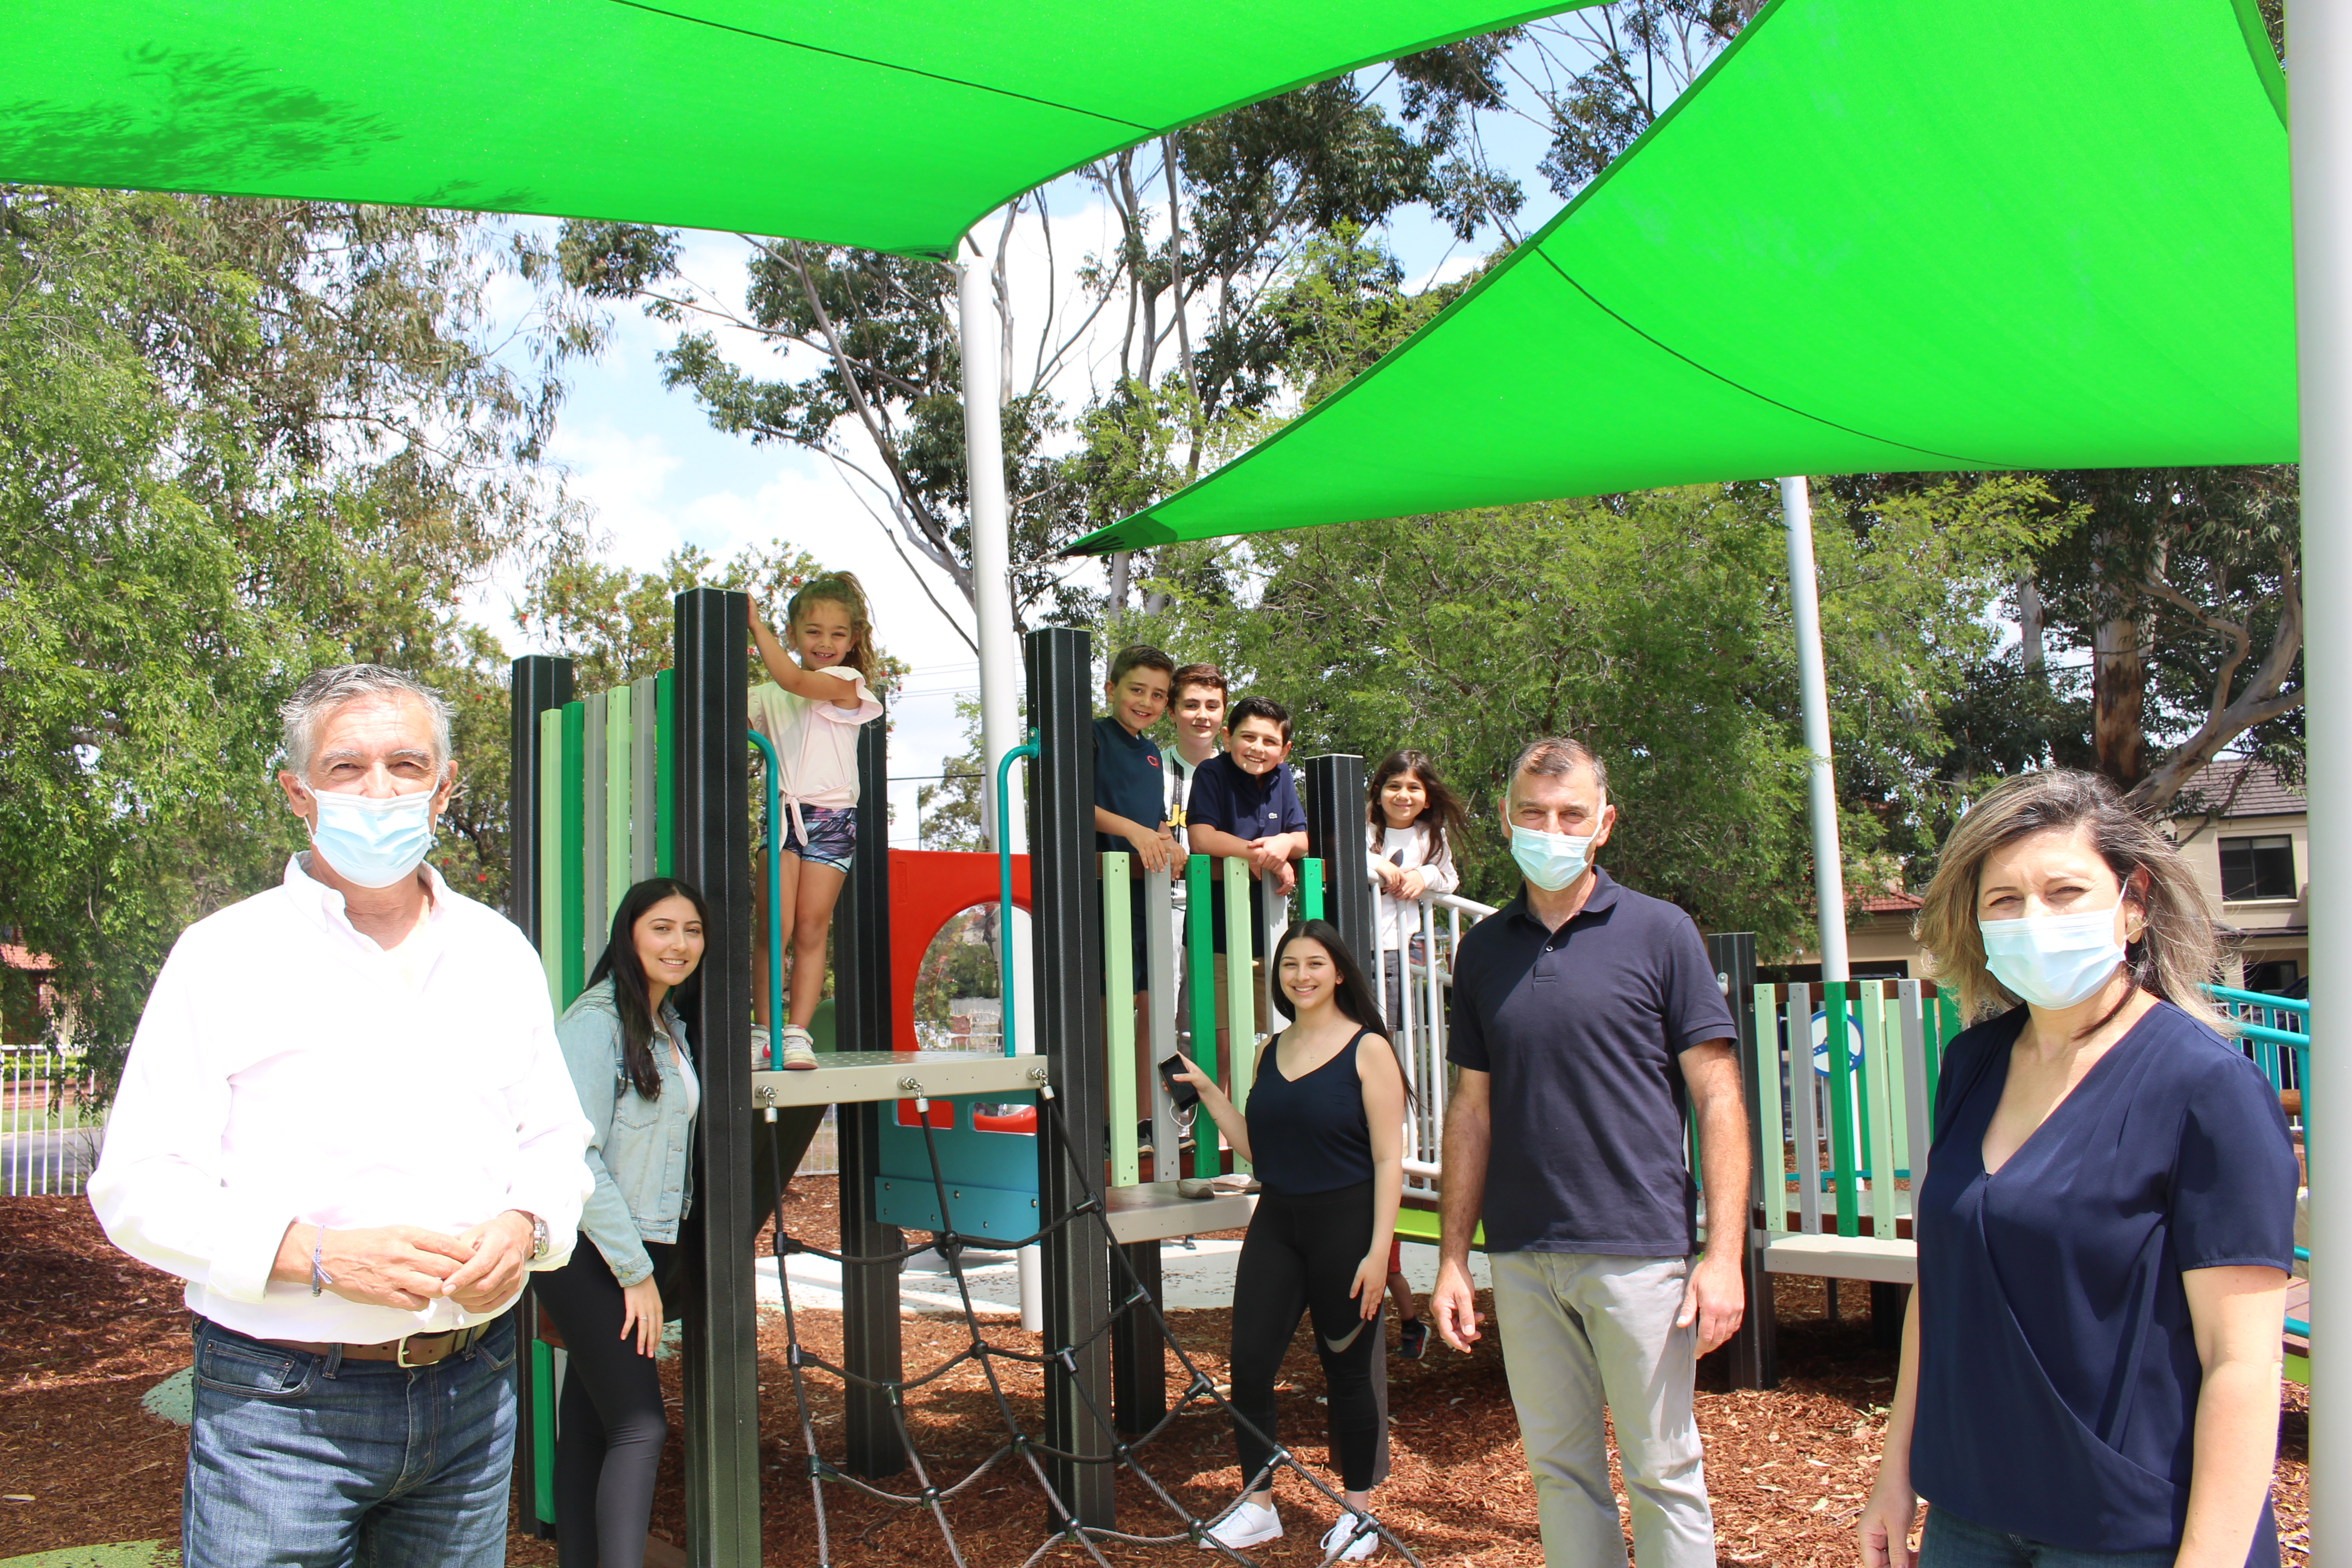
0 0 1581 256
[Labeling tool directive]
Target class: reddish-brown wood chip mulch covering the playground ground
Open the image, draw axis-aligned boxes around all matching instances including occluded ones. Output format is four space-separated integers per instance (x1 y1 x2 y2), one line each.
0 1180 2310 1568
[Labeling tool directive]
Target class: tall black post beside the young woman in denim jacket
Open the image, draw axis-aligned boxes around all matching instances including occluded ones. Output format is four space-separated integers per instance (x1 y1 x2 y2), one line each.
675 588 762 1568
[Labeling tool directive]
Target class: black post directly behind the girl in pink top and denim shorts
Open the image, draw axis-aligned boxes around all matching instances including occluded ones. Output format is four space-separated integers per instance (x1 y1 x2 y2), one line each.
833 720 906 1481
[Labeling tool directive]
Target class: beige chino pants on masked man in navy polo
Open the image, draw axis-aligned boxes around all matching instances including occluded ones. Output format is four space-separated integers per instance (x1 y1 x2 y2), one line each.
1489 1253 1715 1568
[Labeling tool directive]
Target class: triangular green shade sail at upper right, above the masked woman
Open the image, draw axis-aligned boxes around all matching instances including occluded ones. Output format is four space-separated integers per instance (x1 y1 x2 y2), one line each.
1075 0 2296 553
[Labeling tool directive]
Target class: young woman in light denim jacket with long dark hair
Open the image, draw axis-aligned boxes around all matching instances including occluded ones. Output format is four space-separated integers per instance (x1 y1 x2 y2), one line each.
536 877 708 1568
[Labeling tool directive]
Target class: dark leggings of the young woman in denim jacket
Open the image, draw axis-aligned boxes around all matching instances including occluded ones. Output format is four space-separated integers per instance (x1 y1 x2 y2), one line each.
532 1236 673 1568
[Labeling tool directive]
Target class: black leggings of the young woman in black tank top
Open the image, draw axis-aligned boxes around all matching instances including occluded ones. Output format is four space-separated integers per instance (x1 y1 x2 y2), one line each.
1232 1182 1388 1493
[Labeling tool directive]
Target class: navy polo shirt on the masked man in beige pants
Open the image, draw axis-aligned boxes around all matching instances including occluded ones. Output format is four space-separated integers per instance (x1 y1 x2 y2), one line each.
1446 870 1738 1258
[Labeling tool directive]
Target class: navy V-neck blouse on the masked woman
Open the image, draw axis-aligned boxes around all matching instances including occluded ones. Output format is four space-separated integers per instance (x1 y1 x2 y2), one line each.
1912 1001 2296 1566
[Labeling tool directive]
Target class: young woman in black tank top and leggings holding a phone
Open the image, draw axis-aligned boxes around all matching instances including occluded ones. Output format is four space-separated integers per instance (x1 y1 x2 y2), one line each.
1176 919 1406 1563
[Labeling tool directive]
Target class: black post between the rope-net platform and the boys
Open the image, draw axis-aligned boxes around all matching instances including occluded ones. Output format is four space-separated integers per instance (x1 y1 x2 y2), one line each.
1025 627 1115 1530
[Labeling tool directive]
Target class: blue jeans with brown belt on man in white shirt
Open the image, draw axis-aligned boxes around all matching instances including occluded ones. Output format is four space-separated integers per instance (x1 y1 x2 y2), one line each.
181 1314 515 1568
